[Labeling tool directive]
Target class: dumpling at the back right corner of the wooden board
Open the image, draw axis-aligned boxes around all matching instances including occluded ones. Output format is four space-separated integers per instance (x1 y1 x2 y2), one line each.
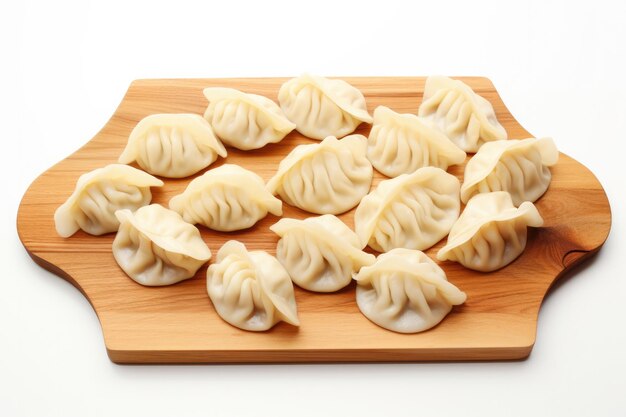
418 76 507 152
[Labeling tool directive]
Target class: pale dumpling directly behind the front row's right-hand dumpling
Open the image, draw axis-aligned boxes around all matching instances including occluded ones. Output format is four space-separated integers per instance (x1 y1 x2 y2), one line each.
354 167 461 252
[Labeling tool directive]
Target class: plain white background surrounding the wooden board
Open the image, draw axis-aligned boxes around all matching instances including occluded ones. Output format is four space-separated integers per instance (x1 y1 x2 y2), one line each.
0 0 626 417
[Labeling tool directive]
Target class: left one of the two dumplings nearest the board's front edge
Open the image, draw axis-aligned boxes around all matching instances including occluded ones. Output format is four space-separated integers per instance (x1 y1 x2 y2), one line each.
206 240 300 331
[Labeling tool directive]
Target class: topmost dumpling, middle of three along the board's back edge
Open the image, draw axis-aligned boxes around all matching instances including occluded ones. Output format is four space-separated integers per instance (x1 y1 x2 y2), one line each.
278 74 372 140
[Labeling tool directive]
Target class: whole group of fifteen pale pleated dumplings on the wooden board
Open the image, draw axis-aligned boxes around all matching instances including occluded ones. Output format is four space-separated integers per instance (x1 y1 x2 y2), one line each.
54 75 558 333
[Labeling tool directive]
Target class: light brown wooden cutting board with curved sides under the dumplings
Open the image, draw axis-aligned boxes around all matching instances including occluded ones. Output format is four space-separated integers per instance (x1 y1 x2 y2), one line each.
17 77 611 363
